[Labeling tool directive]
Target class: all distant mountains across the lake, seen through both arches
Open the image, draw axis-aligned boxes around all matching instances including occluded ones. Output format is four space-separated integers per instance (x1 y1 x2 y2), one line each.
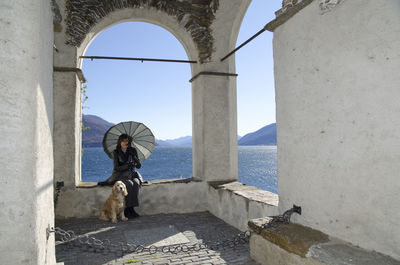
82 114 276 147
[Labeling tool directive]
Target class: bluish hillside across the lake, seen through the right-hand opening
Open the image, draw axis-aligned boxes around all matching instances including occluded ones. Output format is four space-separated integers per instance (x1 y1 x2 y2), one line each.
238 123 276 145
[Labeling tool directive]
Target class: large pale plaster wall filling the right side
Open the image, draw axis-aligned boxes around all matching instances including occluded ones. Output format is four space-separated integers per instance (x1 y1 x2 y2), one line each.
274 0 400 258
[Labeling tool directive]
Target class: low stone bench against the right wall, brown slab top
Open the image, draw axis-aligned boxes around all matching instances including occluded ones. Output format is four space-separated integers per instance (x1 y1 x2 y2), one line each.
248 217 400 265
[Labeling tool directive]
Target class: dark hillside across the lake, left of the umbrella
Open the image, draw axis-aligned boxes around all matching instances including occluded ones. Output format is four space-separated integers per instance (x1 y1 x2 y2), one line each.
82 114 114 147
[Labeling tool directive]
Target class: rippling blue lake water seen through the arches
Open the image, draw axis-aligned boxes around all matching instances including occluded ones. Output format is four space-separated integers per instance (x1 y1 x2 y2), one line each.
82 146 278 193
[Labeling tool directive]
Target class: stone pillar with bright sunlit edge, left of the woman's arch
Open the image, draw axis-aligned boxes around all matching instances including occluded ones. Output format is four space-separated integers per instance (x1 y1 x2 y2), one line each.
53 0 84 188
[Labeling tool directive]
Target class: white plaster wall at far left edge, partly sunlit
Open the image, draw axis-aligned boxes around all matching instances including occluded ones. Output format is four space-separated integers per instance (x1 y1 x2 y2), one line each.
0 0 55 264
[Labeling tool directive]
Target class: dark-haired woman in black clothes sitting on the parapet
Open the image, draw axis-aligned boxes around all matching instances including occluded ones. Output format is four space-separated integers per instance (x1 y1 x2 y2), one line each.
98 134 143 218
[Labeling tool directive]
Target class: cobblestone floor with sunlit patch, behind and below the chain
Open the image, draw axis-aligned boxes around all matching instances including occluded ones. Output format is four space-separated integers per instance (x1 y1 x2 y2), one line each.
56 212 257 265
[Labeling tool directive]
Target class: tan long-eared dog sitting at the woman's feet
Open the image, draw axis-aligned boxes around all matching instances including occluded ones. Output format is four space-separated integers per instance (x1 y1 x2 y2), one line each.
99 181 128 223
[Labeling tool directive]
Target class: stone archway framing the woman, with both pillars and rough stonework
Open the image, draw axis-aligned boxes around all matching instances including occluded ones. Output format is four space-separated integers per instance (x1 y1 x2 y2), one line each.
54 0 251 216
